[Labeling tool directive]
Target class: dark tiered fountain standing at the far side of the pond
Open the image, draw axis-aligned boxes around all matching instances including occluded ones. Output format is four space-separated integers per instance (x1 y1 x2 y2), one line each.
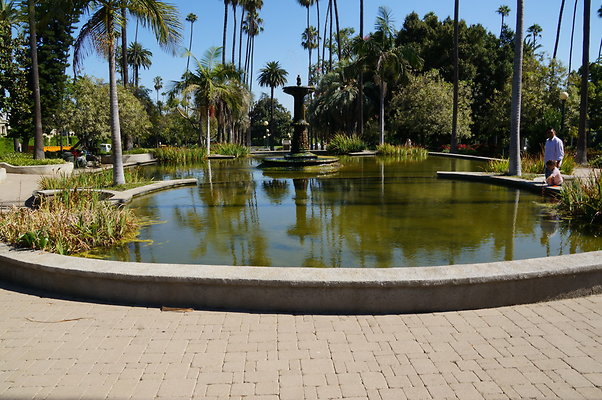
260 76 339 169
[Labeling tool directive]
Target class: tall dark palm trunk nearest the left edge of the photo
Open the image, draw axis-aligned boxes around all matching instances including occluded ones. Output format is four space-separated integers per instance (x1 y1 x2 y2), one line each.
25 0 45 160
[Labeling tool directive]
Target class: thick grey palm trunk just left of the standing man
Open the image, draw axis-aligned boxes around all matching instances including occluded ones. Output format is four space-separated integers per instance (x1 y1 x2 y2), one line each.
509 0 524 176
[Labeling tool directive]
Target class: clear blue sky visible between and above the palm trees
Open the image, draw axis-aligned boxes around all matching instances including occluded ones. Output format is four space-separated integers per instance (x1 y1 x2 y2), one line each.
76 0 602 109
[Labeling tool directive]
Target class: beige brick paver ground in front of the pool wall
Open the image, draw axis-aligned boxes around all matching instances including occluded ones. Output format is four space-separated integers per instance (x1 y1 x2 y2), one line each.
0 284 602 400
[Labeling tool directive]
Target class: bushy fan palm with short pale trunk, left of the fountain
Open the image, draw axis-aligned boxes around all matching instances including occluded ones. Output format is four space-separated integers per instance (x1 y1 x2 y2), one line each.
173 47 248 154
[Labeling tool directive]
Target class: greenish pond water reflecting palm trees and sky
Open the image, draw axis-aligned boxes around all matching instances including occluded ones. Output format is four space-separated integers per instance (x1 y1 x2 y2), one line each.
95 157 602 267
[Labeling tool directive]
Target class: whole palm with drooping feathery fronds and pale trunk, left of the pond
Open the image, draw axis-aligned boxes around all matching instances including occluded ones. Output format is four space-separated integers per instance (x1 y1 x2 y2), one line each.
74 0 181 185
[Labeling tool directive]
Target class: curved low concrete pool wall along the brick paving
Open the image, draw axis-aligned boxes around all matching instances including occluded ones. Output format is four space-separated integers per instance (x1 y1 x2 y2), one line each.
0 244 602 314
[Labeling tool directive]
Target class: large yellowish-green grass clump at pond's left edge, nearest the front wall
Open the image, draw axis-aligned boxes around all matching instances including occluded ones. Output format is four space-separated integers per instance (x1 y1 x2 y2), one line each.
0 190 140 255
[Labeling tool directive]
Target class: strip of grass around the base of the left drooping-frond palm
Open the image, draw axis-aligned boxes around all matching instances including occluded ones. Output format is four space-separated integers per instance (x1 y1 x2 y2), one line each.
39 168 153 190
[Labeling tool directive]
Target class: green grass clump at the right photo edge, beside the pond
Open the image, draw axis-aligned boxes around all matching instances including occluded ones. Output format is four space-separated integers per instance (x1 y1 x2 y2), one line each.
557 171 602 225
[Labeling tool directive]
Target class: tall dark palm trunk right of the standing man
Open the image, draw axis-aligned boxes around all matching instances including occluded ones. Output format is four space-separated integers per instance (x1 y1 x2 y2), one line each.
575 0 592 164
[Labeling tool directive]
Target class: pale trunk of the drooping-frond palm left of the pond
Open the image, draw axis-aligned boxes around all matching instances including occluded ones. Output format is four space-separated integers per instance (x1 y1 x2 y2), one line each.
108 33 125 186
